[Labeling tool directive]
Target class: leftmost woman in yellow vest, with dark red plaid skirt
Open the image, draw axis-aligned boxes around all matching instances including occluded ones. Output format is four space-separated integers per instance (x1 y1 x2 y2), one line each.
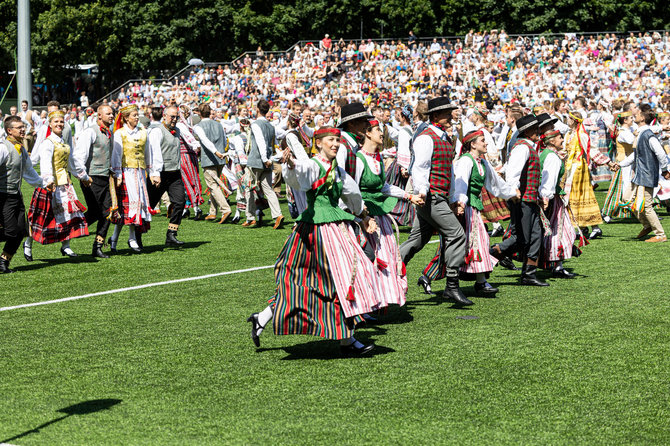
24 110 91 257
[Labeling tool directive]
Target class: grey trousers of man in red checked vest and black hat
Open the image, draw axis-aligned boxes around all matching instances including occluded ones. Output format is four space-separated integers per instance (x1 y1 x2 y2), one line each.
400 194 466 276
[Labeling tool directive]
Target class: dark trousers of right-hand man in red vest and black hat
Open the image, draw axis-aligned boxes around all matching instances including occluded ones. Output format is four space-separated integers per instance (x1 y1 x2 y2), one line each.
500 201 542 262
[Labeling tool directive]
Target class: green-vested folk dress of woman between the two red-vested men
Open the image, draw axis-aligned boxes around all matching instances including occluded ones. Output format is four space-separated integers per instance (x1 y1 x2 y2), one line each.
423 153 516 281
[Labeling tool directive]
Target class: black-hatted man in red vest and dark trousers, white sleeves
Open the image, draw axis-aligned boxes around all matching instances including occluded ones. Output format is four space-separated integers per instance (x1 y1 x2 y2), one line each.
491 115 549 286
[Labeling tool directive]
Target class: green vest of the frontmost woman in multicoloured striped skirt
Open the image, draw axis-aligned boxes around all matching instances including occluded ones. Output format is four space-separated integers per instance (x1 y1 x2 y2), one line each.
296 158 355 225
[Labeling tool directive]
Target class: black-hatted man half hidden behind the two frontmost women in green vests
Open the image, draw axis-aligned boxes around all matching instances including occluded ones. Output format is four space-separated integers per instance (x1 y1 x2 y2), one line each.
337 102 372 177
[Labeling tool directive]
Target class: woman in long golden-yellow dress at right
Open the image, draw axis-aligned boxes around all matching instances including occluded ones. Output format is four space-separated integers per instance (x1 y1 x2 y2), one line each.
565 111 614 239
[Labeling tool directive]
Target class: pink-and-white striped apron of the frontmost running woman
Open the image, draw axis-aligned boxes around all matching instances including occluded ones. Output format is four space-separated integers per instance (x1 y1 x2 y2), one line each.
319 223 387 317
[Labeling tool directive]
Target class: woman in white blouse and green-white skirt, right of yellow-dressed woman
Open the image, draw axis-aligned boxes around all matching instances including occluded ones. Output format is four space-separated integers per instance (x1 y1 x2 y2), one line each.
602 110 635 222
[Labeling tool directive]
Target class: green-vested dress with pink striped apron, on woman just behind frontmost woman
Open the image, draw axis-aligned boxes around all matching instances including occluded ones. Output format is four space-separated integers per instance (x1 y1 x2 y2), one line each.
355 150 407 305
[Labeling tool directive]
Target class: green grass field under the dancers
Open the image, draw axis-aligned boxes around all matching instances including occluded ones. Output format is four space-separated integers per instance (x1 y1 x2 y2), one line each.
0 182 670 445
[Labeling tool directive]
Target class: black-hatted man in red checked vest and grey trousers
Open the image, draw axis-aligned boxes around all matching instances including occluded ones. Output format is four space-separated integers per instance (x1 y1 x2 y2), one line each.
400 97 472 305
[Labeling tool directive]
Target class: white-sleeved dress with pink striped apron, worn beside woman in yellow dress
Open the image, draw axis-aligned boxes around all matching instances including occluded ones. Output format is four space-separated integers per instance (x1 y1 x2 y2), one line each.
539 147 576 267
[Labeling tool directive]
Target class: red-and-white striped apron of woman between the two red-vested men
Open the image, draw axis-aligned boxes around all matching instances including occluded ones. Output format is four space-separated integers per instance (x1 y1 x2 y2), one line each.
461 206 498 274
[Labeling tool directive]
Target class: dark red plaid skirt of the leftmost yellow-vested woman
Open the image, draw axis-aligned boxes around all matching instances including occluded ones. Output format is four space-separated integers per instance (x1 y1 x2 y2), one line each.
28 185 88 245
